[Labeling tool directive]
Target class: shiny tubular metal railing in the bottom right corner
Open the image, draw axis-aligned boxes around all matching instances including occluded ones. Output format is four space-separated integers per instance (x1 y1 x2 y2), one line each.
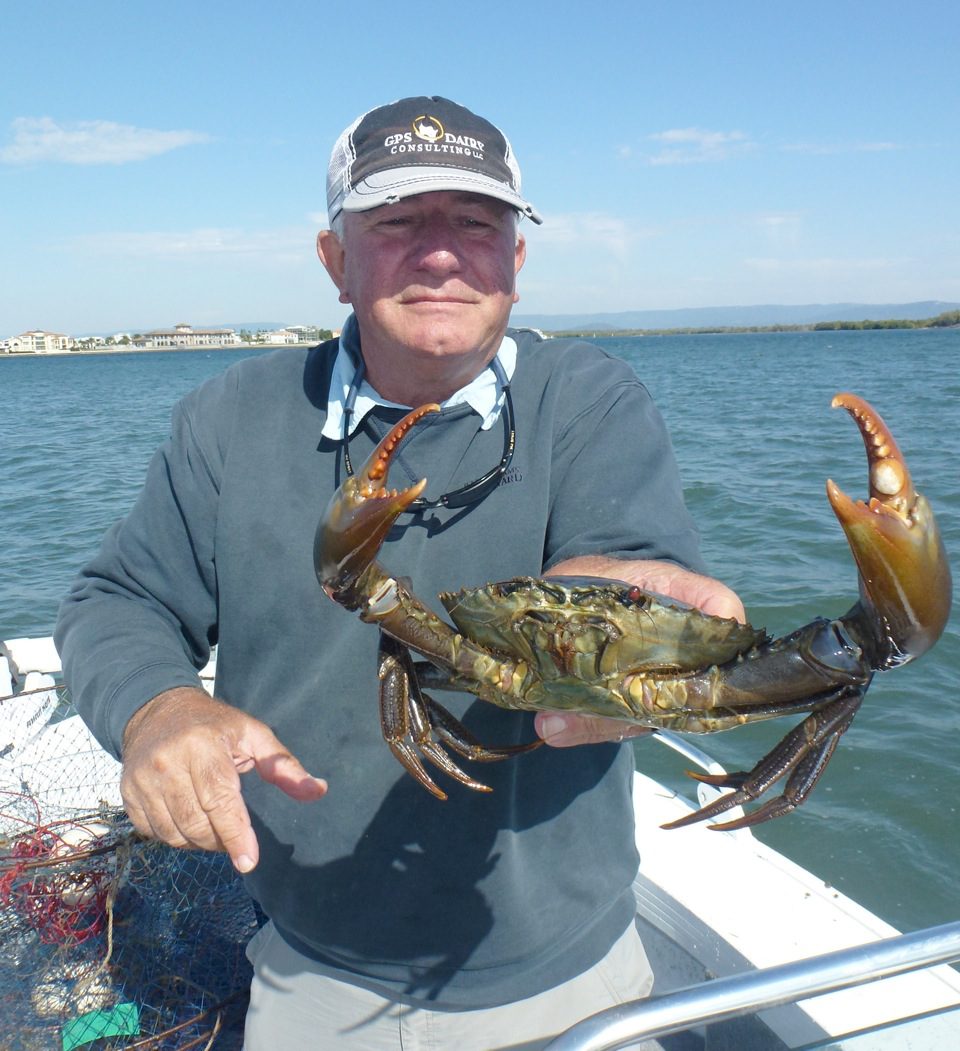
548 921 960 1051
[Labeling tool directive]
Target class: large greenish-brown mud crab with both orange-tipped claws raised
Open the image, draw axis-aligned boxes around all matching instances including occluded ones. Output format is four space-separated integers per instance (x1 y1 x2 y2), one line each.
314 394 952 828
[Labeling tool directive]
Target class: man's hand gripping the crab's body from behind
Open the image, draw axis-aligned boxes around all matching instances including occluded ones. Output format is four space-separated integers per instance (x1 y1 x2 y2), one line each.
534 555 747 748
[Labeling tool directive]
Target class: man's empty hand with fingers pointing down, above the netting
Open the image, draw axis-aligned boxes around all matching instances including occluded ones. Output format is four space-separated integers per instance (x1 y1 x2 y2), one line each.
120 687 327 872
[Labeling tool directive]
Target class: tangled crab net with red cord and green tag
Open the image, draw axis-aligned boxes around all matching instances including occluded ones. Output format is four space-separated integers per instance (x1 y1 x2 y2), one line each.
0 686 259 1051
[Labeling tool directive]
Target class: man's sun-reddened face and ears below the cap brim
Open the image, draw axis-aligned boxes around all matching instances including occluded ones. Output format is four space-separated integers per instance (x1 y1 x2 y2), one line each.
321 191 525 374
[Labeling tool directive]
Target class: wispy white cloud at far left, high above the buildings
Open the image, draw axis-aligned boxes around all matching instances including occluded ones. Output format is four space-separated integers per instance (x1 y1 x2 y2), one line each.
0 117 210 164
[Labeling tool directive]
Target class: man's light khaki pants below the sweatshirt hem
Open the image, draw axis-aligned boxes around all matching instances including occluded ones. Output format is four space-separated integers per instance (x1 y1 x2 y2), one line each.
244 924 658 1051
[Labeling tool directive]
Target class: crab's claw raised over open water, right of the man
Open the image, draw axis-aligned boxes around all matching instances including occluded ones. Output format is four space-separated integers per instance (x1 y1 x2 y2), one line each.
826 394 952 667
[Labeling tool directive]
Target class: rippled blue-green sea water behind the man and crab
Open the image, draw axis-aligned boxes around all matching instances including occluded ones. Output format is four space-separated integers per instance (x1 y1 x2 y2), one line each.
0 330 960 930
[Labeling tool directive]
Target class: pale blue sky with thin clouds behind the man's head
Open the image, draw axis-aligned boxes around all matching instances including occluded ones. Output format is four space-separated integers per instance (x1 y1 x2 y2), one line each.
0 0 960 337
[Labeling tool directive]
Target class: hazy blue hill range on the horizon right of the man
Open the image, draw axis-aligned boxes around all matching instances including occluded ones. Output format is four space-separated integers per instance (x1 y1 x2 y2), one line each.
510 300 960 332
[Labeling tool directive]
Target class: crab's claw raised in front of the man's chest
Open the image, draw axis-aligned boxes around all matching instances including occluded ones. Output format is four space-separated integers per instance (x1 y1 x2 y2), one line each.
313 404 440 601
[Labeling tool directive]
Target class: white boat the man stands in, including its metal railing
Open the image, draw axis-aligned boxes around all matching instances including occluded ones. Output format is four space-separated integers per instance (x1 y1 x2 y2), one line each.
0 638 960 1051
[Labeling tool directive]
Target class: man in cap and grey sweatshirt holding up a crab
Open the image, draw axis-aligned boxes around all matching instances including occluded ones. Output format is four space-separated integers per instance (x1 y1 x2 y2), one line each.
58 98 742 1051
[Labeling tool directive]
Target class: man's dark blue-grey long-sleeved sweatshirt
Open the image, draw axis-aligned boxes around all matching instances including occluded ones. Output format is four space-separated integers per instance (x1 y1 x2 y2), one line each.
57 331 701 1009
